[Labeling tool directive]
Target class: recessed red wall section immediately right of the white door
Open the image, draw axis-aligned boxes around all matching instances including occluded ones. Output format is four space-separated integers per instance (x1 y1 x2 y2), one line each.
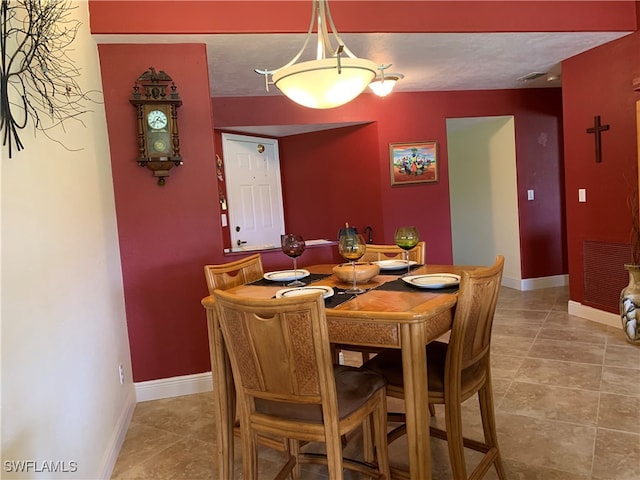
278 124 383 240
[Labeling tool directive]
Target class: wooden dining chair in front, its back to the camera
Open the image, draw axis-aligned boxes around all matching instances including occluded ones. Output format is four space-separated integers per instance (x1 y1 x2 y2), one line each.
214 290 389 480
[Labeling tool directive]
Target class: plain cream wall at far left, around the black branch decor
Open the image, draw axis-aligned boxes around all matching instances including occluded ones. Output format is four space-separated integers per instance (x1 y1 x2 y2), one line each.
0 0 135 479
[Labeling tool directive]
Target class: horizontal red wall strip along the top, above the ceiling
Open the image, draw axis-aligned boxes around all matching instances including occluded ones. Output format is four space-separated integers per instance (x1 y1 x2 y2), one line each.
89 0 636 34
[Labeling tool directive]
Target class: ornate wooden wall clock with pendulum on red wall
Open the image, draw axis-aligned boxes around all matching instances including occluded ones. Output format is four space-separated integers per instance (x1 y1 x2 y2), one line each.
129 67 183 185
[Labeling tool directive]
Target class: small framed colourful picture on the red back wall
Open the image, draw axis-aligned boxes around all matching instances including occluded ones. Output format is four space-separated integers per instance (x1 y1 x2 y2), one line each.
389 142 438 185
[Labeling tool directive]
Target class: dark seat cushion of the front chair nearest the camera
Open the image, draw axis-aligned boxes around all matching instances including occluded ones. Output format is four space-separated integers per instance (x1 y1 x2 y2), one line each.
256 365 386 423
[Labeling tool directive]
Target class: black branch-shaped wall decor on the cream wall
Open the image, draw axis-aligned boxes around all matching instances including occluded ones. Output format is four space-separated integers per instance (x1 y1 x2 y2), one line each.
0 0 95 158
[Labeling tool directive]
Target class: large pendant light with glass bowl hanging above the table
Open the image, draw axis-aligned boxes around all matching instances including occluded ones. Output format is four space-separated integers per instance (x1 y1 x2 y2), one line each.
255 0 378 109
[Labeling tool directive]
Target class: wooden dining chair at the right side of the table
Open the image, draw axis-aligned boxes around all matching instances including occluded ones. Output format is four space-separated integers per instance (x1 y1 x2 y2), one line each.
365 255 506 480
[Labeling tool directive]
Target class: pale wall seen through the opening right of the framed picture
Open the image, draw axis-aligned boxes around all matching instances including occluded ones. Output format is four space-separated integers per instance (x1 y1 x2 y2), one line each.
447 116 522 283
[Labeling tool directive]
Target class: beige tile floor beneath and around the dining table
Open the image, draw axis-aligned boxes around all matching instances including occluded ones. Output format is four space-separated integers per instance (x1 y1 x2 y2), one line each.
111 288 640 480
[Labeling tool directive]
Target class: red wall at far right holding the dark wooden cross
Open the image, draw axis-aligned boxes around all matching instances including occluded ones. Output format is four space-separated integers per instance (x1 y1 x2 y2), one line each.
562 32 640 313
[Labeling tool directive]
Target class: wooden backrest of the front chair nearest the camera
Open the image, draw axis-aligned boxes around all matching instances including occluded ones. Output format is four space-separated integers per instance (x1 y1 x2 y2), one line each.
214 290 335 404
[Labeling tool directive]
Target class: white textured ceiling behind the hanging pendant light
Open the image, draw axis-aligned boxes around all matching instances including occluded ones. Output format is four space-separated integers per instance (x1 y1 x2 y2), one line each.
96 32 631 136
